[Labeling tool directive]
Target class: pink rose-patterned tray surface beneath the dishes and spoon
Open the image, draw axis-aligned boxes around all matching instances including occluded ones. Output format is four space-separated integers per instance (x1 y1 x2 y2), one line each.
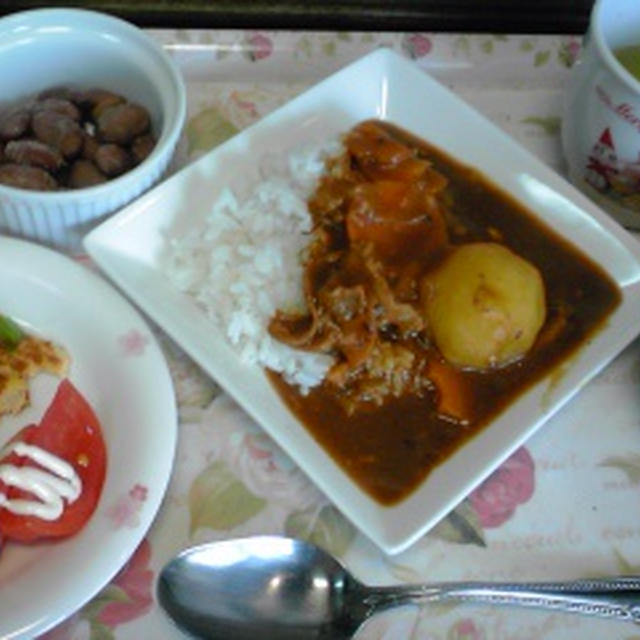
43 30 640 640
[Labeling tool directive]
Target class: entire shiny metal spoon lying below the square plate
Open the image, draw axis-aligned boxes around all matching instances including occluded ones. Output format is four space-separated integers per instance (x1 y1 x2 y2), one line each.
157 536 640 640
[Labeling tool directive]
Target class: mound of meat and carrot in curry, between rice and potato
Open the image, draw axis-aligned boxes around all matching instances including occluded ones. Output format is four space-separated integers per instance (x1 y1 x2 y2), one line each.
269 123 456 413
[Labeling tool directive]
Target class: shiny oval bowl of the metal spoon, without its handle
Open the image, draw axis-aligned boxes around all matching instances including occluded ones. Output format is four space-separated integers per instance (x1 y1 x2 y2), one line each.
158 536 364 640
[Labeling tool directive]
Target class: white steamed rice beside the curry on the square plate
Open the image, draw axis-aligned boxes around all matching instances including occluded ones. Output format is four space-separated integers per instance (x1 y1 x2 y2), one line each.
165 141 340 393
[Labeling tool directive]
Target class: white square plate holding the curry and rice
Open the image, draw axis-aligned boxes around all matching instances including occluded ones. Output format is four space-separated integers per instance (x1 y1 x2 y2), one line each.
85 49 640 554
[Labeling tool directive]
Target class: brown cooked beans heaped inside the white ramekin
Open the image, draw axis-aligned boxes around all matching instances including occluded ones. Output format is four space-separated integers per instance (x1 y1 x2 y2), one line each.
0 86 156 191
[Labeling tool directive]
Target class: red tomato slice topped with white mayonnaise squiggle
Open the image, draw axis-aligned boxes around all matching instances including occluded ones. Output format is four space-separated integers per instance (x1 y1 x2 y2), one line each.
0 379 107 542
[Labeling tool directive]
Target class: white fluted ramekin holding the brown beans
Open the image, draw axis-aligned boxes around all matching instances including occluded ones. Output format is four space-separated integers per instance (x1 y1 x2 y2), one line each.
0 9 186 252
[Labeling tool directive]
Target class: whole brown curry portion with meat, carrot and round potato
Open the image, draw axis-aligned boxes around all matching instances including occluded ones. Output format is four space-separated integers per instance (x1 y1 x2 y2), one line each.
269 121 620 504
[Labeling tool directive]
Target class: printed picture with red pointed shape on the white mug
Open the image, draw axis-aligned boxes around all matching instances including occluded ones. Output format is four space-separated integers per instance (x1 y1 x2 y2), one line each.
584 127 640 211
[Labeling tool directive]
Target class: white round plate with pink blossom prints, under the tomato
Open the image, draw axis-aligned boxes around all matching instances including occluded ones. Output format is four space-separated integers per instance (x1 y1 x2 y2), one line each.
0 237 177 640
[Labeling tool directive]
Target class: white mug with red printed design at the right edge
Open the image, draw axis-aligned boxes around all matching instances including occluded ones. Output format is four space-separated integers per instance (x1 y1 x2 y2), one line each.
562 0 640 229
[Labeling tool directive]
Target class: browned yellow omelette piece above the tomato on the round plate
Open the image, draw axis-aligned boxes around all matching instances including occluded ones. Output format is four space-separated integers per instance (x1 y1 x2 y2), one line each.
0 315 70 416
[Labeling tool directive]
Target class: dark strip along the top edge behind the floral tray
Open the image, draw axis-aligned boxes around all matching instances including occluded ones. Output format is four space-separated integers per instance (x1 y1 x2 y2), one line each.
0 0 593 33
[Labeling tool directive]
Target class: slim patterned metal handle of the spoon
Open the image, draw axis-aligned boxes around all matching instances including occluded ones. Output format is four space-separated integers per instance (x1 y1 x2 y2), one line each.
366 576 640 623
